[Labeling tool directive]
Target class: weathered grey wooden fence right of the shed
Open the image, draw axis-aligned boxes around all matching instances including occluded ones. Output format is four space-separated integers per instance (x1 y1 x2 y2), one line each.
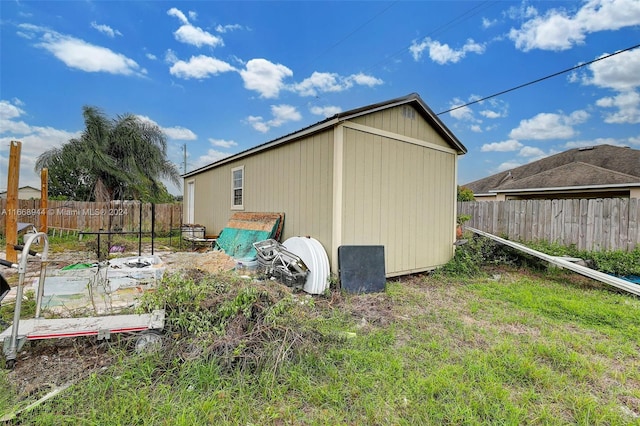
458 198 640 251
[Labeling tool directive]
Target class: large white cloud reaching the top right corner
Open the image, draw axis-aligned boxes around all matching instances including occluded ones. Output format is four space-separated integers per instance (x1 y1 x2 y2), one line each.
509 0 640 52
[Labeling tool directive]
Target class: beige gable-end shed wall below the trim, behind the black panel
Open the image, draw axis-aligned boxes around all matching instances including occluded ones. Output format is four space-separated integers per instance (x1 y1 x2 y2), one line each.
340 128 456 276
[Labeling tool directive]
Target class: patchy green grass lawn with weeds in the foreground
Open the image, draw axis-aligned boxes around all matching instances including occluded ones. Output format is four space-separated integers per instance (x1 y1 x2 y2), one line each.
0 267 640 425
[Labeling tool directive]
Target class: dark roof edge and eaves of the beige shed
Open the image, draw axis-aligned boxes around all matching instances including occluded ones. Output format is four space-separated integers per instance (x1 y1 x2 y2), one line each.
182 93 467 177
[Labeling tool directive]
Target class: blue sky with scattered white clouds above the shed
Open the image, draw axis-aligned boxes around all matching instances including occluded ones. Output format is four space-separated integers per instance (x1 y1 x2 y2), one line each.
0 0 640 194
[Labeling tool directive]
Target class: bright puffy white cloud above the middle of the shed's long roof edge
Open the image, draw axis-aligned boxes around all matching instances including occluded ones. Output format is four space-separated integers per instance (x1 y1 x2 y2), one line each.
240 59 293 99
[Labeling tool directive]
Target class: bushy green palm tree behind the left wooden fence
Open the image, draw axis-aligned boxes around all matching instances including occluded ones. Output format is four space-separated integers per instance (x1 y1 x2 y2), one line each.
35 106 179 202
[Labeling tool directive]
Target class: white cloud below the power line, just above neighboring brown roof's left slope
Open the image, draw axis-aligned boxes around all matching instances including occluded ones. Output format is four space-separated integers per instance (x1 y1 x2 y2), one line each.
509 110 589 140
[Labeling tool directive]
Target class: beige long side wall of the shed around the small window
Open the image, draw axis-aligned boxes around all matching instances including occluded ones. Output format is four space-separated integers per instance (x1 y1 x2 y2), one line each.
185 130 333 253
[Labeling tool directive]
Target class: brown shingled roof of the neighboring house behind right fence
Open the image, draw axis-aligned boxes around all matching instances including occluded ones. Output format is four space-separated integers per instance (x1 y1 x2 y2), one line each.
463 145 640 195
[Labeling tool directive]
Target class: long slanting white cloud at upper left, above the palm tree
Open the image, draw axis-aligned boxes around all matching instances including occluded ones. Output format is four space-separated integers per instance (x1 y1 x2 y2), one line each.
19 24 146 75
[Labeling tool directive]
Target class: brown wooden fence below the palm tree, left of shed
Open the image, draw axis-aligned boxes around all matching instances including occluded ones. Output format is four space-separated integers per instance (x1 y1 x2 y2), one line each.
0 199 182 235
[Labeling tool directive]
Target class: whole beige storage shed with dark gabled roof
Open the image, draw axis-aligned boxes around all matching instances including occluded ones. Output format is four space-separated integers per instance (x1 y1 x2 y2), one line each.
183 93 467 277
